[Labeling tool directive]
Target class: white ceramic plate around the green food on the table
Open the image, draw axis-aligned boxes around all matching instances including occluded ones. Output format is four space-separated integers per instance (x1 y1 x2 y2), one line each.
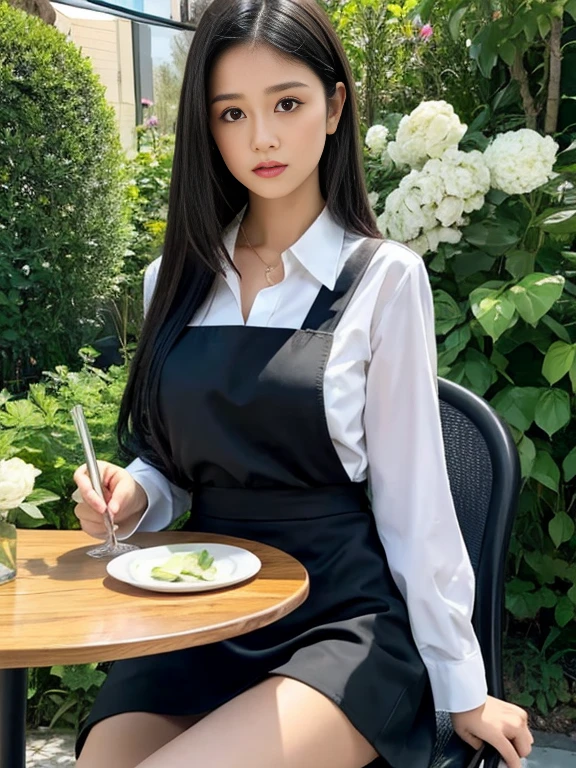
106 542 262 592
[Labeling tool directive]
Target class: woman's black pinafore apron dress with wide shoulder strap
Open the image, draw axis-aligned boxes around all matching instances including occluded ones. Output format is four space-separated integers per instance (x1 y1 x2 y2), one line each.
77 239 436 768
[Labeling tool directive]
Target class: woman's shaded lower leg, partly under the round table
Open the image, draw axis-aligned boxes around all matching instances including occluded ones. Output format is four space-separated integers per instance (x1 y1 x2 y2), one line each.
76 712 209 768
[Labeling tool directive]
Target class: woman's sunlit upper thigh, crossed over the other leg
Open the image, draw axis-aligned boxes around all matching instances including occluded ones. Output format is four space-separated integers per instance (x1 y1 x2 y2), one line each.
135 676 377 768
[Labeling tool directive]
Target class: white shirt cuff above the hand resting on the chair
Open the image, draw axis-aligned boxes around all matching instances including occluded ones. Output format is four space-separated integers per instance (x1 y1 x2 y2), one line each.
424 651 488 712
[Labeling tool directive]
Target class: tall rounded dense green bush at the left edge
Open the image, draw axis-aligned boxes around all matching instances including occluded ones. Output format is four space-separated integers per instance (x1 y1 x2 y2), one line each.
0 2 128 390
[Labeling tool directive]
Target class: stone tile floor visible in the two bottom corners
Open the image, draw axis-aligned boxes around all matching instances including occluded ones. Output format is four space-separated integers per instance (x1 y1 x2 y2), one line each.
26 731 576 768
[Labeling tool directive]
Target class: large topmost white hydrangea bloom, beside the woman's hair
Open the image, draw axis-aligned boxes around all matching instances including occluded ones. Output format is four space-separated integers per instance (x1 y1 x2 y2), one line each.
388 101 467 168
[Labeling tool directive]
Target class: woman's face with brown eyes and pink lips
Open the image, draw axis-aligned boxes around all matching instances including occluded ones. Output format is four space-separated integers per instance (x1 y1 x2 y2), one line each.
208 45 346 198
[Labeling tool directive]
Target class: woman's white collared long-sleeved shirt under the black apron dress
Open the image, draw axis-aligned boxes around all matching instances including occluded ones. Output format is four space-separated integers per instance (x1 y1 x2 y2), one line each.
128 208 487 712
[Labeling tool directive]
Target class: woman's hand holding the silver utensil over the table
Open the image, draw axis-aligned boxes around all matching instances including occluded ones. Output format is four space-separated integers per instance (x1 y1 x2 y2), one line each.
72 461 148 539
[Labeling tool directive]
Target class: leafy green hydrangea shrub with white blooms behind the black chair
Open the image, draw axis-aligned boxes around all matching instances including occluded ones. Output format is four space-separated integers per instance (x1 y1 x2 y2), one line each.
366 102 576 713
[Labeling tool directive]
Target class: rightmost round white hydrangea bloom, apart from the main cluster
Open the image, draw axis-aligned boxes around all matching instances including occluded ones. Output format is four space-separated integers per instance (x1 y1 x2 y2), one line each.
484 128 558 195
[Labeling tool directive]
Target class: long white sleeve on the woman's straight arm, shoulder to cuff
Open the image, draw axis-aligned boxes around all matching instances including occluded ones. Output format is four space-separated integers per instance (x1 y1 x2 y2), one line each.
364 261 487 712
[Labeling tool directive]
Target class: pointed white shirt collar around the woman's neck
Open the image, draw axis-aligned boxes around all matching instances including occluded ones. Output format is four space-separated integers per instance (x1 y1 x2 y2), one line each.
223 206 344 291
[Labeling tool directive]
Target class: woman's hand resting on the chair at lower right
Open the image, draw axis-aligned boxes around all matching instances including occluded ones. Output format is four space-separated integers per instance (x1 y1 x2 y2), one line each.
450 696 534 768
